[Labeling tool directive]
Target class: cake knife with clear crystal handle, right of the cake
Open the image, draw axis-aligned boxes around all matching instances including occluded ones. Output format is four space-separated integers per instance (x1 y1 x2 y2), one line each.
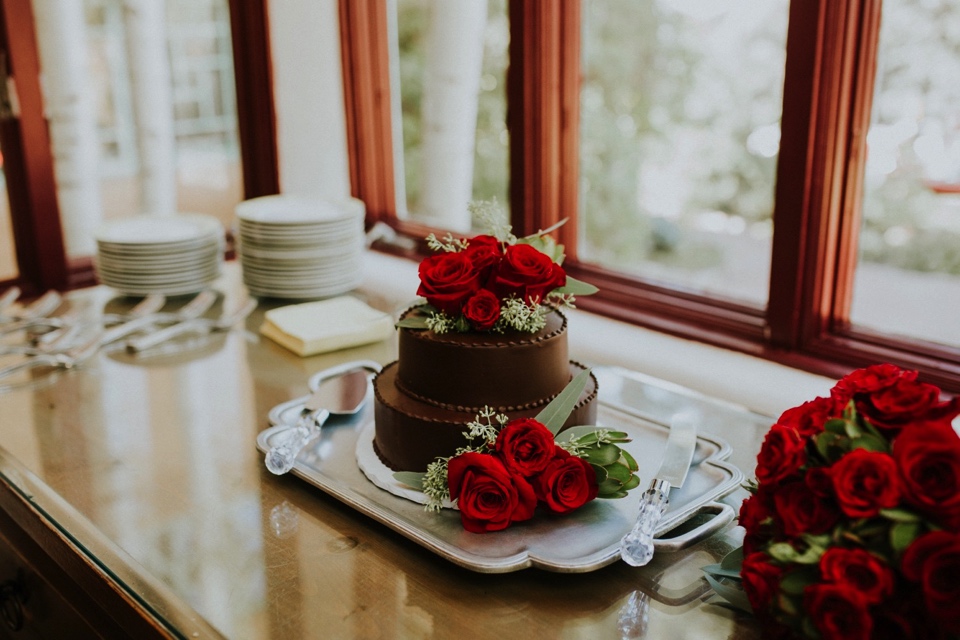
620 412 697 567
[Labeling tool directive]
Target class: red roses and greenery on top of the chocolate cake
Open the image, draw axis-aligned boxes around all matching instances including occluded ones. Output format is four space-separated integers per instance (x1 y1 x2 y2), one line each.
397 201 597 333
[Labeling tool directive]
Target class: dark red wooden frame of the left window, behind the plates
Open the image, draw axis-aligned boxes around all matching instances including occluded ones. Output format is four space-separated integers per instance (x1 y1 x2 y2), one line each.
0 0 280 296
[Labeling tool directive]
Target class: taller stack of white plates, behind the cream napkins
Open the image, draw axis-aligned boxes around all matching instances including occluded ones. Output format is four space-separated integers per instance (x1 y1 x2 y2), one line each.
236 195 366 299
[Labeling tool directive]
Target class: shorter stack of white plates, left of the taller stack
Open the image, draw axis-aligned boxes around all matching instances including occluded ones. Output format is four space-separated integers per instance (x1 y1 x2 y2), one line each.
94 213 224 296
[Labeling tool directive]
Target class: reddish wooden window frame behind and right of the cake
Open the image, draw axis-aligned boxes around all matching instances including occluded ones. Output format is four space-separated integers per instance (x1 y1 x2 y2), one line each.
340 0 960 393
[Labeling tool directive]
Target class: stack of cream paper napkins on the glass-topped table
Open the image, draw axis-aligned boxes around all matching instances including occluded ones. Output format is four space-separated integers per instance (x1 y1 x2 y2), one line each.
260 296 394 356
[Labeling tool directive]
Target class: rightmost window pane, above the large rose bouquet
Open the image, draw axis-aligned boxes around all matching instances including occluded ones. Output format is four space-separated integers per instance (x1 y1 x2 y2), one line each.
851 0 960 346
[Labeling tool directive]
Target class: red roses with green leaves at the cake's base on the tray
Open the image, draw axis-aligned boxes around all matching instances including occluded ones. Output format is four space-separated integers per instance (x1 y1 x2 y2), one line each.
394 371 640 533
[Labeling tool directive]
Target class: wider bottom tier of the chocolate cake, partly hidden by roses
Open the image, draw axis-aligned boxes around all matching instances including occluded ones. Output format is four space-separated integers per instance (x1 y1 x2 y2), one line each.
373 362 597 471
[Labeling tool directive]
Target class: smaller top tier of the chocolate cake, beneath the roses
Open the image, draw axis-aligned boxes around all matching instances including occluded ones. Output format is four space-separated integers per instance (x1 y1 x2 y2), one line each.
396 309 570 411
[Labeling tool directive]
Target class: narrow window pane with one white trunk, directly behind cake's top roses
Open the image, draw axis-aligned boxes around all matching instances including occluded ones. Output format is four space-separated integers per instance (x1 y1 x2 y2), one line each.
393 0 510 231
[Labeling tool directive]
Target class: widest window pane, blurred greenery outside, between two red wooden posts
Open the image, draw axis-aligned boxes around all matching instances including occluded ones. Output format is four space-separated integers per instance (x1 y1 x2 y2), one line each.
578 0 788 305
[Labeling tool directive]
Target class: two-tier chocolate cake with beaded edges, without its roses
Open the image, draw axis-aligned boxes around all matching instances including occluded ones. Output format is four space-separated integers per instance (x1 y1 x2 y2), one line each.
373 310 597 471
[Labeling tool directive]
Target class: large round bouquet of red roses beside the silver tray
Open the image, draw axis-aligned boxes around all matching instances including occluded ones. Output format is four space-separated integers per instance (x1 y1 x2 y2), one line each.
704 364 960 640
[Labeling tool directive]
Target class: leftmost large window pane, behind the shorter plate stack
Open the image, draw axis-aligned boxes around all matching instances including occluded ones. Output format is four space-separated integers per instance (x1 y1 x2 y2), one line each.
34 0 243 256
